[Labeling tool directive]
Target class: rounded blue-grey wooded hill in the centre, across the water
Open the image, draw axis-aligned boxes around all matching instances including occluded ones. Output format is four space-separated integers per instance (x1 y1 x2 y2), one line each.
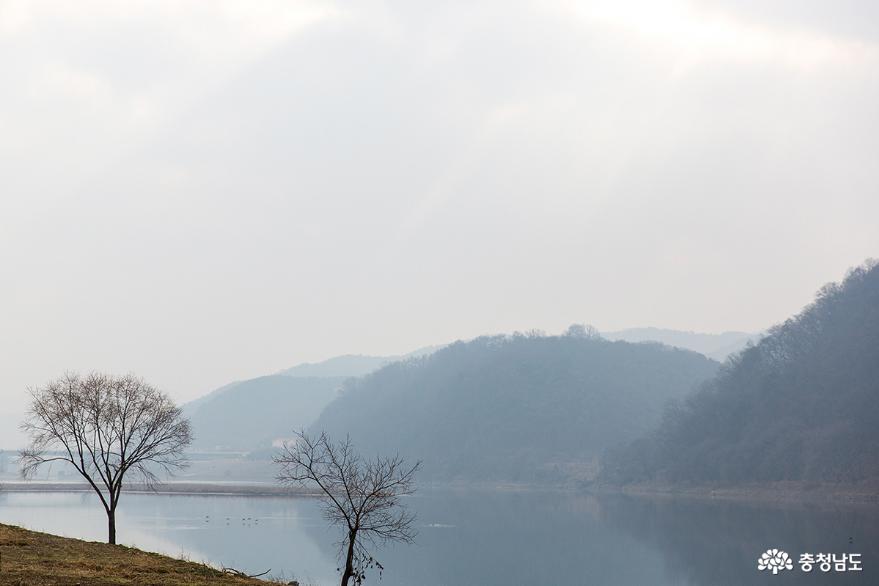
312 335 718 481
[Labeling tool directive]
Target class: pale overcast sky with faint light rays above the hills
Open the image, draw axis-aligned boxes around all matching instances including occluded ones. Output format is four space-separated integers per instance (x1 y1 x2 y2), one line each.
0 0 879 443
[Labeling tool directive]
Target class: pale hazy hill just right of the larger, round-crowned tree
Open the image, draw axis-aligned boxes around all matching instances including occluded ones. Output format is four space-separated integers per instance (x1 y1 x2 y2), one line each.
184 374 346 451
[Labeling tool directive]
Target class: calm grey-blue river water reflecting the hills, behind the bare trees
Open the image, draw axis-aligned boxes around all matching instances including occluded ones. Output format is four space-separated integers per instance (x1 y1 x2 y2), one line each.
0 491 879 586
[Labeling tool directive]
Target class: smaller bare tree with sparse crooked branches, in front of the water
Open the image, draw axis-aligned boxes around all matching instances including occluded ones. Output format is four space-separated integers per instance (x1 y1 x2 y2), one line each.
275 431 421 586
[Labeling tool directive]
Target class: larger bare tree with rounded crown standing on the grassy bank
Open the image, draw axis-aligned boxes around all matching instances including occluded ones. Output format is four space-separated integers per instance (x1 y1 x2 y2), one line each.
20 373 192 543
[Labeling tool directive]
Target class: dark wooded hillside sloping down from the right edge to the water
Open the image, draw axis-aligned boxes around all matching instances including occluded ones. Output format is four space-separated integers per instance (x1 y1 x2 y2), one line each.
603 263 879 484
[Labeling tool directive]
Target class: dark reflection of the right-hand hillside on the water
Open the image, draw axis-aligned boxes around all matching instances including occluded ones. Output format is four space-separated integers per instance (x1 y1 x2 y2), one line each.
601 496 879 586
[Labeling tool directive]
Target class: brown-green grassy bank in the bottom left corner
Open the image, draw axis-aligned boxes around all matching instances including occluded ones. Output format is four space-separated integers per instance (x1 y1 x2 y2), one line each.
0 525 266 586
